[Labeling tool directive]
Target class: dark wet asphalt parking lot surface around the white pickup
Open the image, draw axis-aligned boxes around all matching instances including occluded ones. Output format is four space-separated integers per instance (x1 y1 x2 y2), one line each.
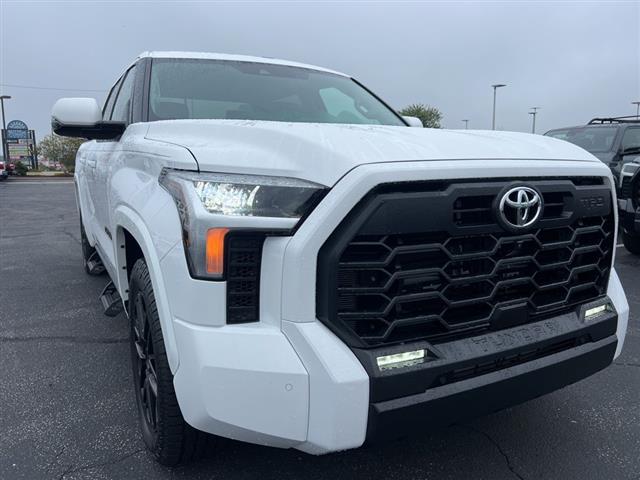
0 179 640 480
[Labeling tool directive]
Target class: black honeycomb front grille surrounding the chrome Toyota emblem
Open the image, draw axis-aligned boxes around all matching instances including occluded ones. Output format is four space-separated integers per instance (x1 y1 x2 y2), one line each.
317 179 614 347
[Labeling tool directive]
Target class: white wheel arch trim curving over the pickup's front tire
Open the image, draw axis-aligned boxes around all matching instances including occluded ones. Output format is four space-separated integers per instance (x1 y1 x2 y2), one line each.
113 206 179 373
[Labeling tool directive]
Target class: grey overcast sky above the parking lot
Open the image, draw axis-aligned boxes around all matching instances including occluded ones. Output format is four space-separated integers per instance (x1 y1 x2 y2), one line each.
0 0 640 138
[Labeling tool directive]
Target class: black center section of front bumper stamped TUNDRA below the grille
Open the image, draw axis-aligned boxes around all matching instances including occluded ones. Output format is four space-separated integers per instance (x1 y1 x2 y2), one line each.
361 306 618 441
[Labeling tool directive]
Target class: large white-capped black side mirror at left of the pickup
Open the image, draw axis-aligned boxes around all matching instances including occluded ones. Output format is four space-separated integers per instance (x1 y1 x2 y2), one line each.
51 98 127 140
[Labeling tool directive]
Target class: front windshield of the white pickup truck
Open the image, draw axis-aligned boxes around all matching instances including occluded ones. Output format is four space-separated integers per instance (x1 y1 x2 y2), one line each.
149 59 405 126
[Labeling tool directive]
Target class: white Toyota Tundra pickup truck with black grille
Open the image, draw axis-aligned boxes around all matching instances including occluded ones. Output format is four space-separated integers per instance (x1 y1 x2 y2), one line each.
52 52 628 465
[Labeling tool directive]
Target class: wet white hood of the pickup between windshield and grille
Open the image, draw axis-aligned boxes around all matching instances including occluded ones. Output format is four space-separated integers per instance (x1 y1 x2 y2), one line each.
146 120 599 186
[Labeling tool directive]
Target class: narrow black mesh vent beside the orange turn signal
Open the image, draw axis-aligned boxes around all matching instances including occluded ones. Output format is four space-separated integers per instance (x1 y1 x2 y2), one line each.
225 233 264 323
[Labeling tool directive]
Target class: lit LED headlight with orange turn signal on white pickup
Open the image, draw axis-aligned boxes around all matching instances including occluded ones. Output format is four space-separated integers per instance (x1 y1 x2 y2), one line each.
159 169 328 279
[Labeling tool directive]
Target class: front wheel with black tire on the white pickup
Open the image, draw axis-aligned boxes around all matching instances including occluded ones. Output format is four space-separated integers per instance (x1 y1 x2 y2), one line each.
129 259 211 466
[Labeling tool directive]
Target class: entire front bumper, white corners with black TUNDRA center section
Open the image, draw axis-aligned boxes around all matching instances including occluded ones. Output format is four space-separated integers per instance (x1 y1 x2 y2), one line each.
174 282 628 454
